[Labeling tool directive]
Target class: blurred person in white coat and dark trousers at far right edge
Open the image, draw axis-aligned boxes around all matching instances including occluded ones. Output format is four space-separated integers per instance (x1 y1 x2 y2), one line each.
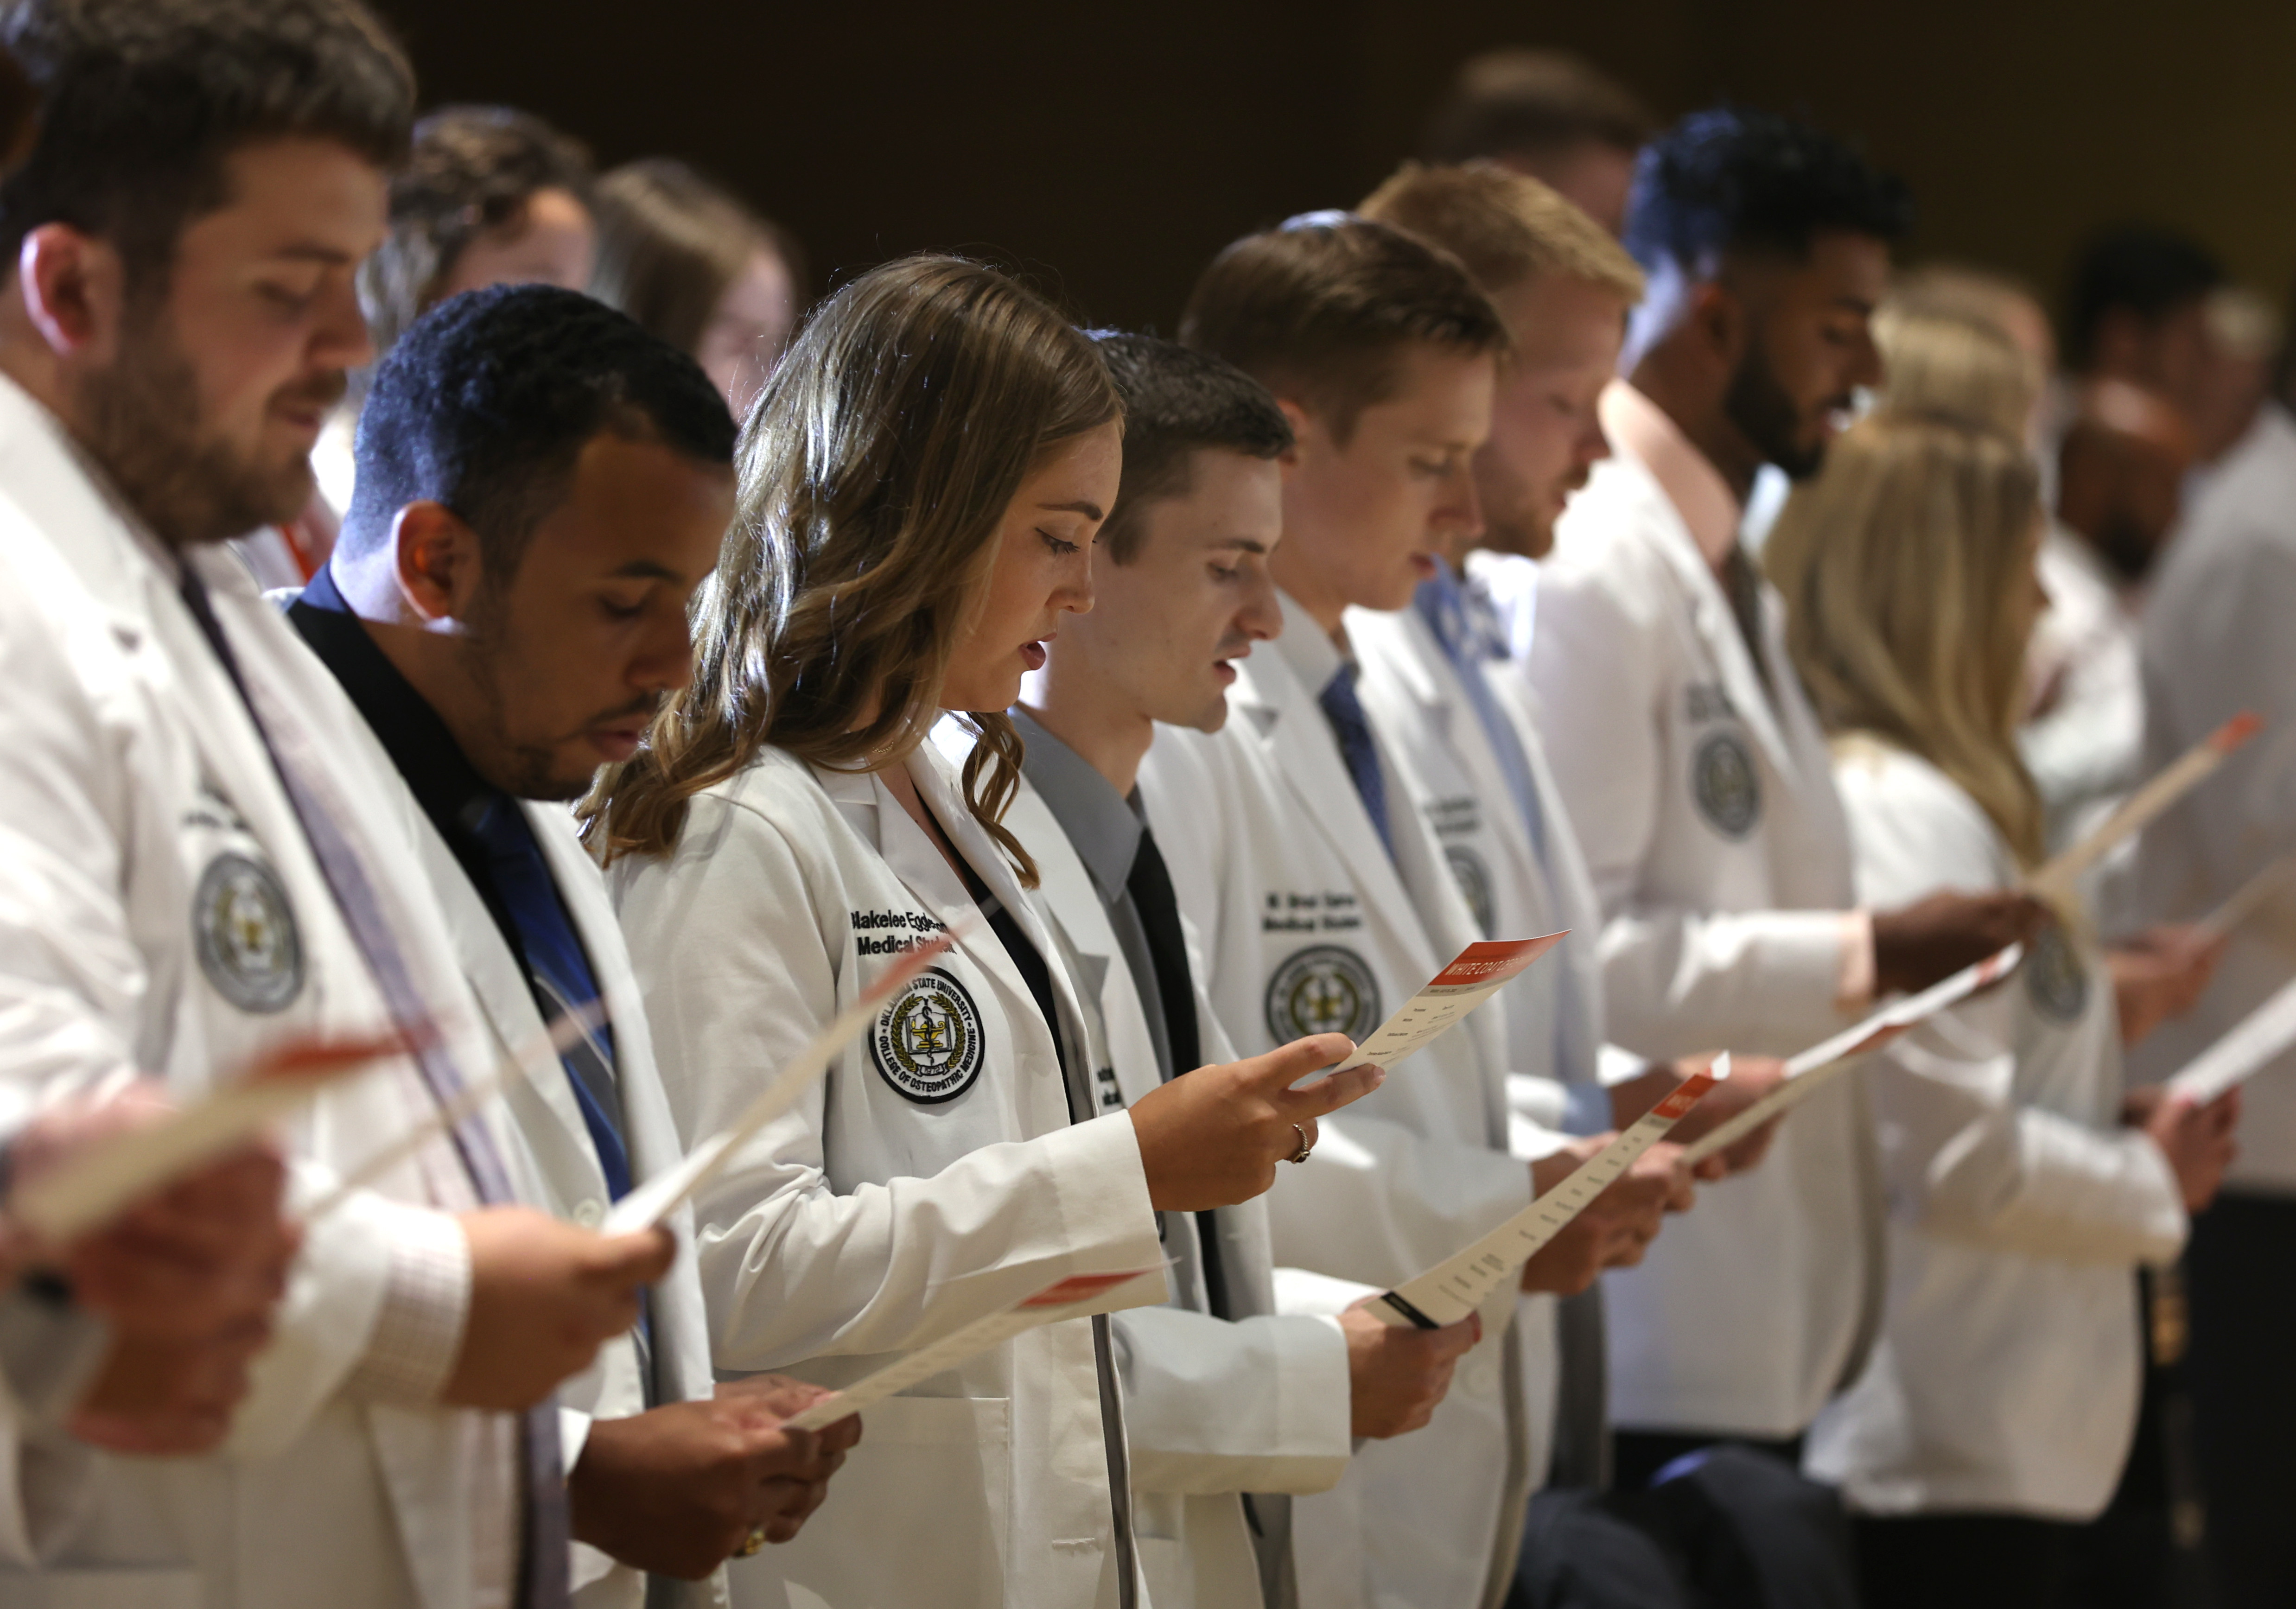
2133 244 2296 1609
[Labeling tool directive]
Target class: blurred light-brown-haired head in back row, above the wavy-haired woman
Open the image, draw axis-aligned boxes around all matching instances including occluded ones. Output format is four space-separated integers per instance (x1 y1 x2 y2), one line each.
590 156 806 420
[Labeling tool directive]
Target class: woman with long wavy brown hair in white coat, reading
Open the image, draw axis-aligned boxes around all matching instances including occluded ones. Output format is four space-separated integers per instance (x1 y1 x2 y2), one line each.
590 257 1378 1609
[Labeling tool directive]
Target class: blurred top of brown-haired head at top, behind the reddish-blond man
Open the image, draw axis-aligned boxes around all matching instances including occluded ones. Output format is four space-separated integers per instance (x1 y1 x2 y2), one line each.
1419 48 1658 234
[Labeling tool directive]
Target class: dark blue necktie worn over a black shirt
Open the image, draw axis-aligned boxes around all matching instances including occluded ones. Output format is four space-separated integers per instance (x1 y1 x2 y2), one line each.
471 794 629 1201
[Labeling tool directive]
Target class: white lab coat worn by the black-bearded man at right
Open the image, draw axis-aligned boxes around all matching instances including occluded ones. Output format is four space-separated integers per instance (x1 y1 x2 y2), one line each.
1527 452 1881 1439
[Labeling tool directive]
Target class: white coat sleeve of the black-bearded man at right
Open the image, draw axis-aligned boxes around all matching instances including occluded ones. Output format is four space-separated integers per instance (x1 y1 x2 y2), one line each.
1527 555 1864 1061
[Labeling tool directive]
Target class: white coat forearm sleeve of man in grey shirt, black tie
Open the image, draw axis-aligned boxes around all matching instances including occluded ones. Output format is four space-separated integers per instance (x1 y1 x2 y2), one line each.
1111 1306 1350 1496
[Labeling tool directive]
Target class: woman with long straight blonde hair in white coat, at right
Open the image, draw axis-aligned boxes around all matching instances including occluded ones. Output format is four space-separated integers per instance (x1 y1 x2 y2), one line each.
1766 408 2236 1609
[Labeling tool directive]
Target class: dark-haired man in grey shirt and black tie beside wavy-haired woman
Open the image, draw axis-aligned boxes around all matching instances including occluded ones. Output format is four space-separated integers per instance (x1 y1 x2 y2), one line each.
1005 333 1474 1609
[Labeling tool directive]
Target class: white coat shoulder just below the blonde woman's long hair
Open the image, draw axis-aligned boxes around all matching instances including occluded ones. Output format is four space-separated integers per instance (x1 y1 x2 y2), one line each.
1832 732 2016 904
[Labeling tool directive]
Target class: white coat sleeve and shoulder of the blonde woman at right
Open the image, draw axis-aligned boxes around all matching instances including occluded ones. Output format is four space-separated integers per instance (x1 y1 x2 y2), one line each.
1841 760 2186 1265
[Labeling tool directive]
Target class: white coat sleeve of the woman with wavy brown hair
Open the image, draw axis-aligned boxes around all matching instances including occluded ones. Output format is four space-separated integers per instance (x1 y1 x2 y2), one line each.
620 794 1162 1370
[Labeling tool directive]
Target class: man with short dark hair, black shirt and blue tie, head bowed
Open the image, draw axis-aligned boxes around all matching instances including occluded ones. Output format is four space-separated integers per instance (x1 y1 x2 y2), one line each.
289 285 859 1609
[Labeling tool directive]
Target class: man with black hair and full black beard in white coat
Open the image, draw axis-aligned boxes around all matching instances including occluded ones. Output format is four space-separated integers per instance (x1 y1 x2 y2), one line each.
1529 108 2039 1514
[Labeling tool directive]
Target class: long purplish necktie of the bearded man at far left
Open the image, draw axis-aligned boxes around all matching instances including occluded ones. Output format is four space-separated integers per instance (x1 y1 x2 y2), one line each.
184 565 574 1609
